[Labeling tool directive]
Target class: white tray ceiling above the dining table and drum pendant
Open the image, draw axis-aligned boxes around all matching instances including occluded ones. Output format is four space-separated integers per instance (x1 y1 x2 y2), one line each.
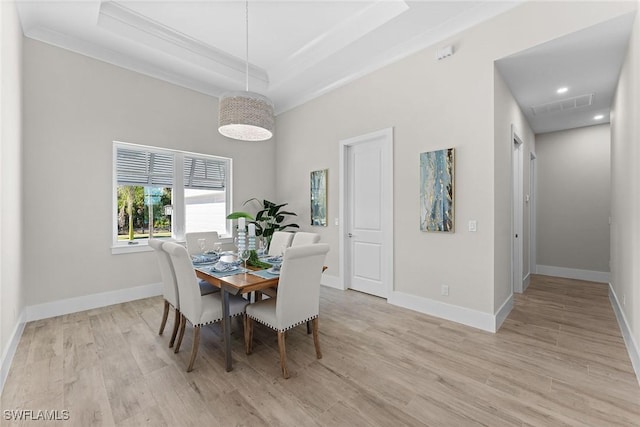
18 0 522 113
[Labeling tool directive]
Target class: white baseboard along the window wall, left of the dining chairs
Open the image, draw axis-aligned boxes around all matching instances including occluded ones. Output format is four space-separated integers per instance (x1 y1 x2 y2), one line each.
26 283 162 322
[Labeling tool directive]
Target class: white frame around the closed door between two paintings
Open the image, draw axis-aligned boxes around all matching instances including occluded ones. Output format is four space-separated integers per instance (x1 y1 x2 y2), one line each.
338 127 394 299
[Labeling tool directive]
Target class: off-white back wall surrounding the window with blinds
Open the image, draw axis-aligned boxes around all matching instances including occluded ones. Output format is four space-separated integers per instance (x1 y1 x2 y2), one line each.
24 39 275 306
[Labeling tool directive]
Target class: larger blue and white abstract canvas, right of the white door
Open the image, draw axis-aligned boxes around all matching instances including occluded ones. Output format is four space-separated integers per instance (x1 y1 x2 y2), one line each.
420 148 455 232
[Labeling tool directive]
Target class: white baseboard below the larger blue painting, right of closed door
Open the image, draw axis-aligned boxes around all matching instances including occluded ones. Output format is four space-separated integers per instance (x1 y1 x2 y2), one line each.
387 291 500 332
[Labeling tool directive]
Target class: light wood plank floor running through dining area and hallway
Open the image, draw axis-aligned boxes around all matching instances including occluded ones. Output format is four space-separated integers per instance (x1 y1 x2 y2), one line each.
0 276 640 427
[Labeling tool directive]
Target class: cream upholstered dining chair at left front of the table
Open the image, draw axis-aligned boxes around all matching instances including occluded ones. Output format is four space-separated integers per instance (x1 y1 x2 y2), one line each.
162 242 248 372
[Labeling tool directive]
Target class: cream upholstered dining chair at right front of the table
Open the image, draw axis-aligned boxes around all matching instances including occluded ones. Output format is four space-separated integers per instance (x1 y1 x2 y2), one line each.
244 243 329 378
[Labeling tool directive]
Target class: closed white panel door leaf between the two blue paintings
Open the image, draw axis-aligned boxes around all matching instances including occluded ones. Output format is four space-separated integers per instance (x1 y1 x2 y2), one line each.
346 138 390 298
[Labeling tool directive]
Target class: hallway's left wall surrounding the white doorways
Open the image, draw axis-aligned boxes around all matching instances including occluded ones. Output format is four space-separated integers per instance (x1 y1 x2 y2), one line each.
494 69 536 310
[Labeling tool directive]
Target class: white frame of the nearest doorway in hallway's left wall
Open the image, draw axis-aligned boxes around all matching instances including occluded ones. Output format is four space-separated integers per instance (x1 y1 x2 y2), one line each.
510 124 524 293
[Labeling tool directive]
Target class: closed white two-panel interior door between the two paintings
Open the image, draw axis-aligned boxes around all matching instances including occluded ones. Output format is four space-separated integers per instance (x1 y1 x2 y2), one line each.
343 129 393 298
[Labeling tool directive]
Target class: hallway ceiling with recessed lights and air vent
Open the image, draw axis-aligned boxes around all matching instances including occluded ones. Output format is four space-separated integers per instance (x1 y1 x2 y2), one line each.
496 13 634 133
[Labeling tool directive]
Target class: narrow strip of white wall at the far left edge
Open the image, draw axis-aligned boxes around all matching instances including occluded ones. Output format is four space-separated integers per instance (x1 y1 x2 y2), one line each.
0 2 24 390
